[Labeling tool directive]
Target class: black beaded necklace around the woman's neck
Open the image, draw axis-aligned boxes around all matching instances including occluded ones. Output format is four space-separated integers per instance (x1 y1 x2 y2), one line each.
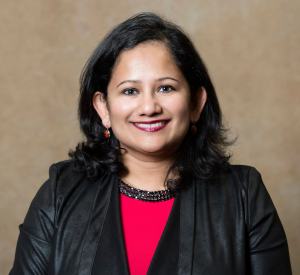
119 178 177 202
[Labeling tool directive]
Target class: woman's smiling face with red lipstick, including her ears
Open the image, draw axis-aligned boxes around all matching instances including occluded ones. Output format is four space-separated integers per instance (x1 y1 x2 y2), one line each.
94 42 206 161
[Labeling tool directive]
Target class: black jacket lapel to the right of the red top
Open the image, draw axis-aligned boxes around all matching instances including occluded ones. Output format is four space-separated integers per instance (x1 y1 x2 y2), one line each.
147 180 195 275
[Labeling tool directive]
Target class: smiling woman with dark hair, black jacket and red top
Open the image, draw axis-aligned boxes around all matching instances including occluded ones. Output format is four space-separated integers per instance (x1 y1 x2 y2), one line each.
10 13 291 275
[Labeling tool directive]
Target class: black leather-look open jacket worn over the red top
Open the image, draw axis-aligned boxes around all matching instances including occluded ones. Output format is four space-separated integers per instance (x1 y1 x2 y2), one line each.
10 161 292 275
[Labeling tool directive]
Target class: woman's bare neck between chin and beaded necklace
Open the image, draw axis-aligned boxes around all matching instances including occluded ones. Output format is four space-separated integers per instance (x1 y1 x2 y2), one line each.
119 151 178 191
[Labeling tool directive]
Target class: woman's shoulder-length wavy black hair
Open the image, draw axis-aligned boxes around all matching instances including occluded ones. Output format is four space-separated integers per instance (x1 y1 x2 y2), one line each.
69 12 234 187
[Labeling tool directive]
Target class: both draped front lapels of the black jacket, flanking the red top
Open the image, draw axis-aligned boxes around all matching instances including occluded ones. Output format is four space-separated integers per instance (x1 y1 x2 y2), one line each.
78 174 195 275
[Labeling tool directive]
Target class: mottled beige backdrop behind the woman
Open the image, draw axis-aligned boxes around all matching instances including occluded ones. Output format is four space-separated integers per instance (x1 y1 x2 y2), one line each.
0 0 300 274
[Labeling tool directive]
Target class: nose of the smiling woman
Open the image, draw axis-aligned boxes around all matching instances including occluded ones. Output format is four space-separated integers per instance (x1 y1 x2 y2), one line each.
139 93 162 116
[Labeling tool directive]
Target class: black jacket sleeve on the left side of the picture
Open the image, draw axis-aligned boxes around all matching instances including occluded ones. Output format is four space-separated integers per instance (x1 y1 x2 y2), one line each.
9 164 58 275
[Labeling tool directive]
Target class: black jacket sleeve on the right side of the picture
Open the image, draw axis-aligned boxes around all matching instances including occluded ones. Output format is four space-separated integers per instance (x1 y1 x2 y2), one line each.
247 168 292 275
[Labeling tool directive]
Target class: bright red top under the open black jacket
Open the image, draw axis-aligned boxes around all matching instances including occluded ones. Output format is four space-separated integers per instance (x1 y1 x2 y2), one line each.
120 194 175 275
